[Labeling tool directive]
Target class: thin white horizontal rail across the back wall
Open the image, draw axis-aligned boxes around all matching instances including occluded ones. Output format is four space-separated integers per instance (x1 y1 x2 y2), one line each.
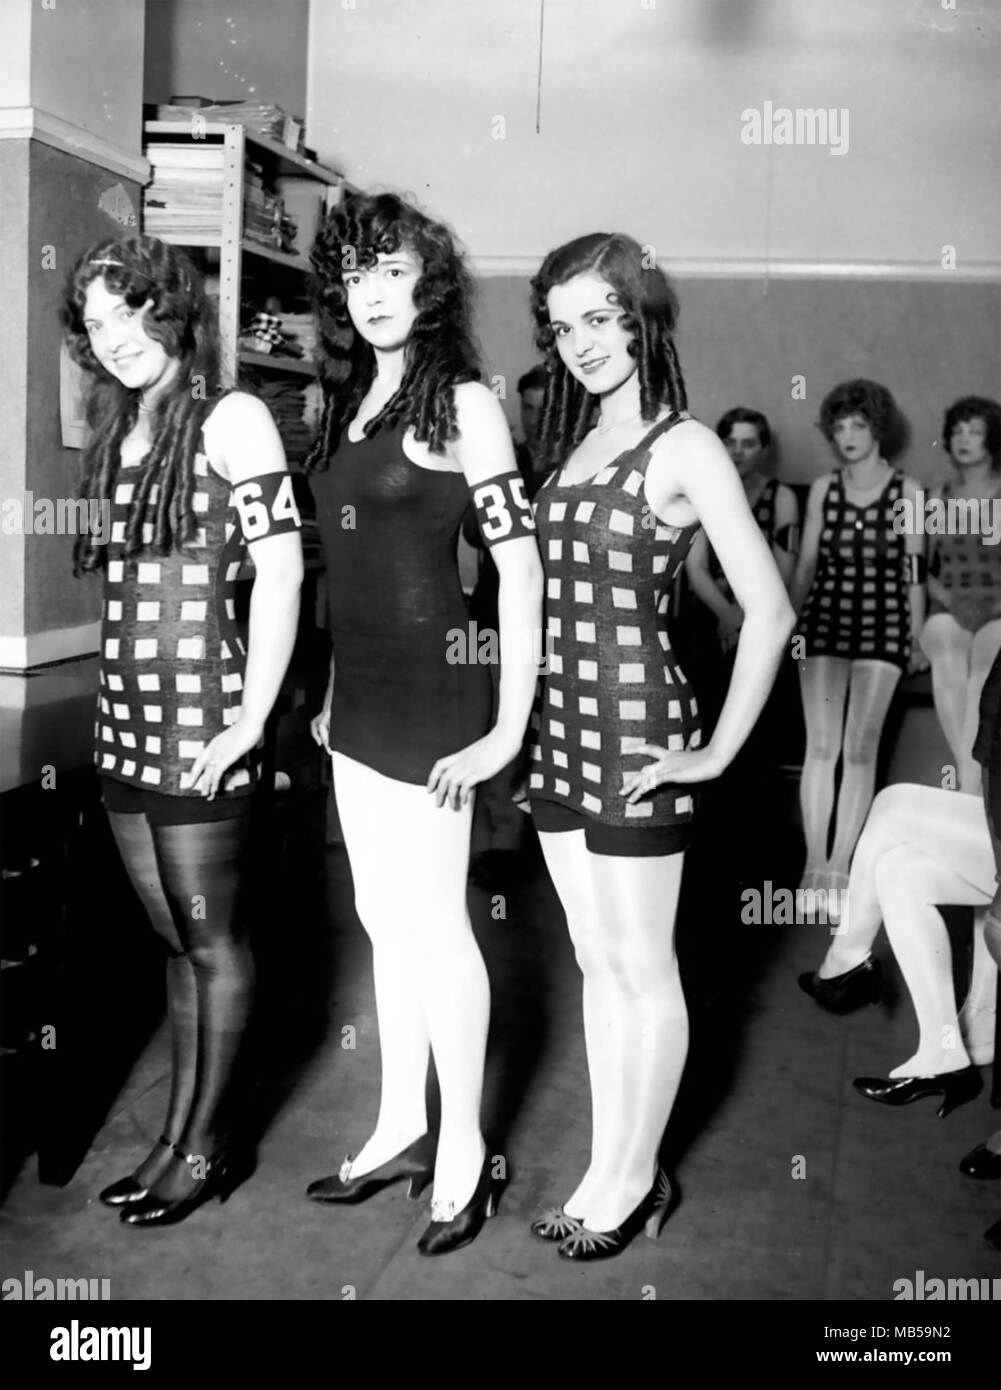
471 252 1001 284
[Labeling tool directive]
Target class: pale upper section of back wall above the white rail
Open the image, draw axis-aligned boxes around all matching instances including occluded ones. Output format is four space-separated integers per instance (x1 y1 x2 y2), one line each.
307 0 1001 270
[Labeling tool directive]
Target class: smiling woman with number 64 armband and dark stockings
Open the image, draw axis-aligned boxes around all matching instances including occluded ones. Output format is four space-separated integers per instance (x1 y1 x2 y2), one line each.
64 236 302 1226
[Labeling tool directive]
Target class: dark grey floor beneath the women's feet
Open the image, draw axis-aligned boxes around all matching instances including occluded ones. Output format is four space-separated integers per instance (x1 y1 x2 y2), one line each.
1 712 998 1301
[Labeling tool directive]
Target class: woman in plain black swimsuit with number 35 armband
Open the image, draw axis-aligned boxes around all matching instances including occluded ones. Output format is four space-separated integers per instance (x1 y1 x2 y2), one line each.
309 193 541 1255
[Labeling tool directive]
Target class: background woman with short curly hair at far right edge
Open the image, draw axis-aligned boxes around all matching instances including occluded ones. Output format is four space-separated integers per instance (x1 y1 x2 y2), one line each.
920 396 1001 791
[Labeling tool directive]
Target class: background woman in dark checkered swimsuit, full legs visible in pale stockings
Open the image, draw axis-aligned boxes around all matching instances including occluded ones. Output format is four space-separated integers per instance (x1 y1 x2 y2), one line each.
791 379 925 891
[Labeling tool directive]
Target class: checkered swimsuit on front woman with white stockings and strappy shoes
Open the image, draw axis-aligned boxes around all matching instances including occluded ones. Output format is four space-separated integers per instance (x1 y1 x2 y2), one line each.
528 414 701 827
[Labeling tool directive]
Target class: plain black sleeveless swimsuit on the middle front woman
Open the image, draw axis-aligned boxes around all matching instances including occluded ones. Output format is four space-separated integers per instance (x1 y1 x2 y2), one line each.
310 424 491 784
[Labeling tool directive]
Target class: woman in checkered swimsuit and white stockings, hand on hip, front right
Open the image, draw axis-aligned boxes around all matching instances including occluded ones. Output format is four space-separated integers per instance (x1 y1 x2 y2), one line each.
528 234 792 1261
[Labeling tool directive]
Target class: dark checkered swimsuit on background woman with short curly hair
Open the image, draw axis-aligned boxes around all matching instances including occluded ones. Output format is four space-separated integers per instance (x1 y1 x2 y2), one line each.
802 471 911 669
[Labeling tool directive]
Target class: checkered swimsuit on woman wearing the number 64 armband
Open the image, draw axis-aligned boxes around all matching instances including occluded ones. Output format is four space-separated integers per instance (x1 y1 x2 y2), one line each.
95 441 260 819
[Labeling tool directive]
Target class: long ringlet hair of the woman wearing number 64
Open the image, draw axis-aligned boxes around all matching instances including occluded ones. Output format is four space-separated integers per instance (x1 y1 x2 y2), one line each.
63 236 220 574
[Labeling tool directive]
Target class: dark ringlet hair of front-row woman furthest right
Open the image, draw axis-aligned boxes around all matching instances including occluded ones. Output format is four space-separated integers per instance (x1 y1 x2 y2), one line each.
531 232 688 467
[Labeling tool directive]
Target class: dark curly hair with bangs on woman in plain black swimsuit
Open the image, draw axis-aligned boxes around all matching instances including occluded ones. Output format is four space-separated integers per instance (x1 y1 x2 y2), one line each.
304 192 481 471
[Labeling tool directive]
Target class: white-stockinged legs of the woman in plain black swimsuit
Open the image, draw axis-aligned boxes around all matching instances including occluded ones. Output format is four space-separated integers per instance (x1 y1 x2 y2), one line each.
334 753 489 1211
